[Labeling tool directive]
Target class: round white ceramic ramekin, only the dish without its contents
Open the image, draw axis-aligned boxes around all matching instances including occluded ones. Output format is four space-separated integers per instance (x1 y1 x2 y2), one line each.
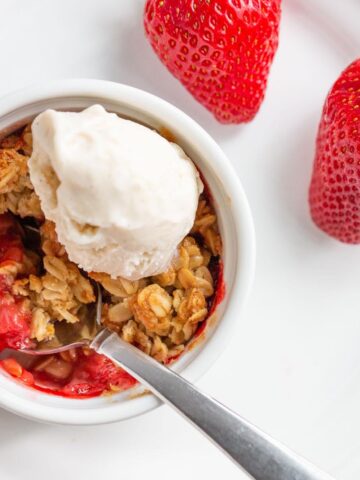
0 79 255 425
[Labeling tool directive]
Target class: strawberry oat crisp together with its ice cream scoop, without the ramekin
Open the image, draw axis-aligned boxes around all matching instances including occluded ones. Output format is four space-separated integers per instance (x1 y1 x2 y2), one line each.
0 105 224 398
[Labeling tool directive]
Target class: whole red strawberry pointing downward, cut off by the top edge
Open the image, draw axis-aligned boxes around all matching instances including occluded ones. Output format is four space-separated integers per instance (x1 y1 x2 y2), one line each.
144 0 281 123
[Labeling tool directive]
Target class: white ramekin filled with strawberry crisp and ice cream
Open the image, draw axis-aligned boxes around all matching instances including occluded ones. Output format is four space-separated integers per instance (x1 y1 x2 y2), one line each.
0 80 254 424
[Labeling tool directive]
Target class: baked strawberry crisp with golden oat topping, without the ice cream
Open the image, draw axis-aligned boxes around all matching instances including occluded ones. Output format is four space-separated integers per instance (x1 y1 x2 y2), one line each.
0 125 223 398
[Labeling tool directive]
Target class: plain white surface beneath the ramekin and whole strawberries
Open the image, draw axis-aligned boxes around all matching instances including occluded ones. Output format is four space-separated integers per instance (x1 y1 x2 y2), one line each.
0 0 360 480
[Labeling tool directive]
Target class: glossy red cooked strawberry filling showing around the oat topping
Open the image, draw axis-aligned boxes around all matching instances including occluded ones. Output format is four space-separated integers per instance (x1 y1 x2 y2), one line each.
0 214 225 398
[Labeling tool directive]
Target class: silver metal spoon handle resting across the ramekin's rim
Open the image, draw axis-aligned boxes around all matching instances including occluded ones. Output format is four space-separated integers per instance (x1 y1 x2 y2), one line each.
91 329 332 480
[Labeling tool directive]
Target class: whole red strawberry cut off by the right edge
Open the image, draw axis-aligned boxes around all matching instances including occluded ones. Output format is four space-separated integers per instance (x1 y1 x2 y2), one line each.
309 59 360 243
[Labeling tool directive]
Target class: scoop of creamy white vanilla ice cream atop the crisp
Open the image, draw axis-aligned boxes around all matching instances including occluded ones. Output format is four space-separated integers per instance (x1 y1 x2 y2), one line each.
29 105 203 280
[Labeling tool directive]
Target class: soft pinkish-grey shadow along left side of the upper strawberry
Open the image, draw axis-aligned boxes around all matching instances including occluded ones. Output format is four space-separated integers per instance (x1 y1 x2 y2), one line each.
108 6 242 139
